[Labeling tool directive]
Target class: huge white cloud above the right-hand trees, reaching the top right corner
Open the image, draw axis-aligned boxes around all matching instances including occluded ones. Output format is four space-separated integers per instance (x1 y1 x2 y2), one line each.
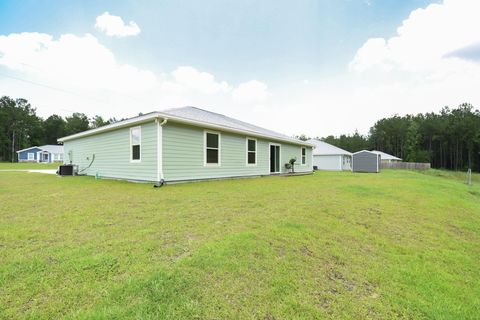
334 0 480 132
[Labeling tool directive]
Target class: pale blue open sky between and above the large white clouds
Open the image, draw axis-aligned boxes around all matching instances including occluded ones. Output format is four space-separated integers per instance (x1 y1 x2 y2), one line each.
0 0 432 83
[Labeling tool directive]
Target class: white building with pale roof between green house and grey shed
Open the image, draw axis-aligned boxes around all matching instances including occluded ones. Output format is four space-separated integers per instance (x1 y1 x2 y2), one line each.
307 139 352 171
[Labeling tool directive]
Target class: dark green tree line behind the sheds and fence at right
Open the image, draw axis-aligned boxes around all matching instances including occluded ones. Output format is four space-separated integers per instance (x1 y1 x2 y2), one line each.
300 103 480 171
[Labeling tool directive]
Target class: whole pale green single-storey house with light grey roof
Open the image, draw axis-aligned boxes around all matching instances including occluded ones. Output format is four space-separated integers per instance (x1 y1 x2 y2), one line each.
58 107 313 184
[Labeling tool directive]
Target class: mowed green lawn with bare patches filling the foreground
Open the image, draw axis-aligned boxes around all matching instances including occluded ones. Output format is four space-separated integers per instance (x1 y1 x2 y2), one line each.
0 171 480 319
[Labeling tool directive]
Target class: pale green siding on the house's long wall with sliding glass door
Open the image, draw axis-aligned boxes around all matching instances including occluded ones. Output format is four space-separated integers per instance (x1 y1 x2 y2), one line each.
163 122 311 182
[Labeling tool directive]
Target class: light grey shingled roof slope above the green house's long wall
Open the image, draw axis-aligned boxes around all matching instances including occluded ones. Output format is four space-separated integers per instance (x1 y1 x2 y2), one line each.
160 107 304 142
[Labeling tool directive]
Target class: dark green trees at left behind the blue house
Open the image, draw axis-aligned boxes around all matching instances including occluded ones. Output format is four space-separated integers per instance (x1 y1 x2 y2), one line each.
0 96 117 161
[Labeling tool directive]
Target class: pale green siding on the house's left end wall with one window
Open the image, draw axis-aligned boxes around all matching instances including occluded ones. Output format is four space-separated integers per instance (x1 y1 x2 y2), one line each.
64 122 157 181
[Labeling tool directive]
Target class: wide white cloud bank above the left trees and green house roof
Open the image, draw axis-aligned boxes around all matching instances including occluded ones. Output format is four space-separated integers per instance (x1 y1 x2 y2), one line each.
0 33 267 121
